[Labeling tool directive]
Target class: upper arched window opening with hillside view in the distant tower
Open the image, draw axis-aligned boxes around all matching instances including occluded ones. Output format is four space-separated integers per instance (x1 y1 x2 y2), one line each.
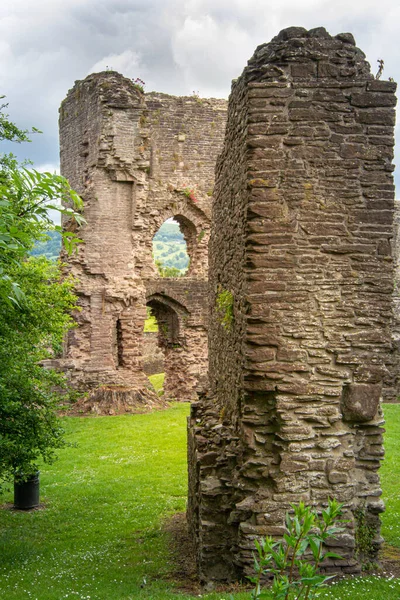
153 215 196 277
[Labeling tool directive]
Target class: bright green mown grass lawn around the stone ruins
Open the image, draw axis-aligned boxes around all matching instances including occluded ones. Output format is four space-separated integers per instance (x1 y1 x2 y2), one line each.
0 404 400 600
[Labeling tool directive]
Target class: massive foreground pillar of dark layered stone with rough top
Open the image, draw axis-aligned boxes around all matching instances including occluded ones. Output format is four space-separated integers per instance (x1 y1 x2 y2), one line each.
188 27 396 581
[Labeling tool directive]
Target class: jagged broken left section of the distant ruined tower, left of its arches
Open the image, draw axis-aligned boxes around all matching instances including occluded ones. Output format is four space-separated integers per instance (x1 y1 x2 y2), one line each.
60 72 160 413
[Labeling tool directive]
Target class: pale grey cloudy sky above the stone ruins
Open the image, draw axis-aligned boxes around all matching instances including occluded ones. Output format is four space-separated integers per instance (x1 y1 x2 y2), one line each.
0 0 400 190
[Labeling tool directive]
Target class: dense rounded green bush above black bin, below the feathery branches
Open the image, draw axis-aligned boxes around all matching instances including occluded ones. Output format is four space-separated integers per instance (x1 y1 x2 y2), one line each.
0 258 76 481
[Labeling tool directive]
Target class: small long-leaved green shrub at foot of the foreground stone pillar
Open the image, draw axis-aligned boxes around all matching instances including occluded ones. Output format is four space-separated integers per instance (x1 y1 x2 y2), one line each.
250 500 343 600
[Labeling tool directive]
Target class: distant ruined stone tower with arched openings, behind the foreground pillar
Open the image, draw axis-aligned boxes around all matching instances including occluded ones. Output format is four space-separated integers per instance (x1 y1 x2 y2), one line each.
60 71 226 411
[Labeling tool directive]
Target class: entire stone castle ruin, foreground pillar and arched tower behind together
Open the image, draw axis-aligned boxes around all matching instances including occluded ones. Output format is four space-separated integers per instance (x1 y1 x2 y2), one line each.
60 27 396 581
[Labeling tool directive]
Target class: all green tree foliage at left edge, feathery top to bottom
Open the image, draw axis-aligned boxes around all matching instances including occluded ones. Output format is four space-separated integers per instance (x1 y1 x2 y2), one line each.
0 98 83 482
